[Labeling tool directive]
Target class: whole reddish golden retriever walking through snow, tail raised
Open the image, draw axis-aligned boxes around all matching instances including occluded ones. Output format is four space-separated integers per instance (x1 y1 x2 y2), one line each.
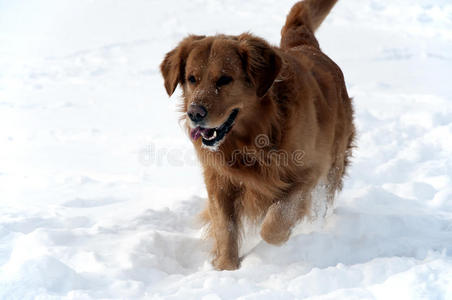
161 0 355 270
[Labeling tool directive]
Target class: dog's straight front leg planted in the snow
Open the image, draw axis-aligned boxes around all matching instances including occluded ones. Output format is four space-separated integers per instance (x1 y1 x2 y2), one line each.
208 176 240 270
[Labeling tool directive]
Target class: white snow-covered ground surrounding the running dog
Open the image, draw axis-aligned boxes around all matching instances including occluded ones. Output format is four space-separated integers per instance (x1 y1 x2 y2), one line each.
0 0 452 300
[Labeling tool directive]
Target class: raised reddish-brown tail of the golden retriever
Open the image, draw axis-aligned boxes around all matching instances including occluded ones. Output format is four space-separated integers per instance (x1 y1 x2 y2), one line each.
281 0 337 49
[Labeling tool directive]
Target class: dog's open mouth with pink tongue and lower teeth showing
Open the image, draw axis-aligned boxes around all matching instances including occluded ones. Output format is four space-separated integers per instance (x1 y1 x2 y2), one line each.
190 109 239 147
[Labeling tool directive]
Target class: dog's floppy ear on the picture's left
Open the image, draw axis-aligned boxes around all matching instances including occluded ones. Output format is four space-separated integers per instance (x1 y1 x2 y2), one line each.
160 35 205 96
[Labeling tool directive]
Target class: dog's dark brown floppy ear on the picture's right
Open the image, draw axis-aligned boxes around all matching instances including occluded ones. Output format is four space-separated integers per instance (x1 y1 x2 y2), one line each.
238 33 282 98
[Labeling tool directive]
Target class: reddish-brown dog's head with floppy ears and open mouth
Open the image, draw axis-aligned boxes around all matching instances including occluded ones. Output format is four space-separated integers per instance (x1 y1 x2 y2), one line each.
161 34 281 147
